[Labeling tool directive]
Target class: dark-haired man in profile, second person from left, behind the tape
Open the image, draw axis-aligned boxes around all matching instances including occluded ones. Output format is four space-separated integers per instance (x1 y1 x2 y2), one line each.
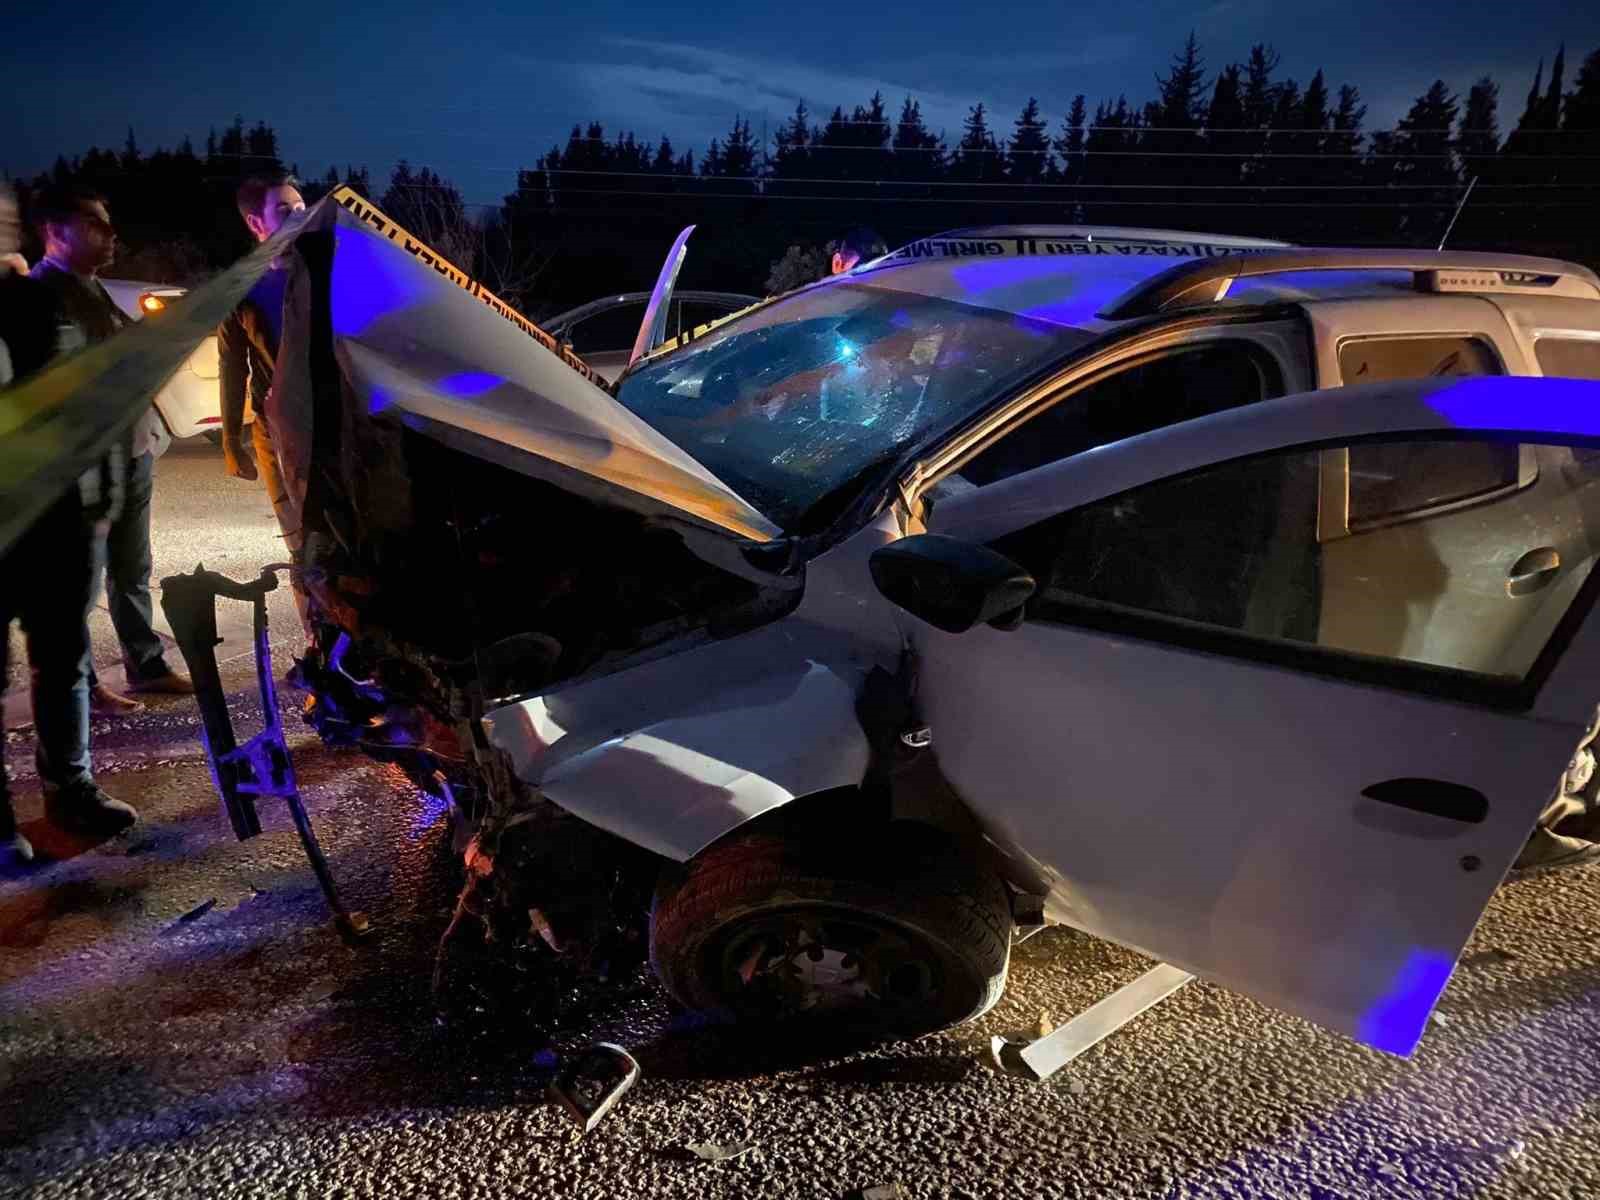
30 189 194 714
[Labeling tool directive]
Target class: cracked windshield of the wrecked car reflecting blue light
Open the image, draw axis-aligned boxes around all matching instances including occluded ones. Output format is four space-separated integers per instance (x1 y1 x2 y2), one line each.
618 283 1083 531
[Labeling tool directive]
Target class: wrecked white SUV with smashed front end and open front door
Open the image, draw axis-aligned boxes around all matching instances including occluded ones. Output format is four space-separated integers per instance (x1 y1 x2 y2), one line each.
34 195 1600 1053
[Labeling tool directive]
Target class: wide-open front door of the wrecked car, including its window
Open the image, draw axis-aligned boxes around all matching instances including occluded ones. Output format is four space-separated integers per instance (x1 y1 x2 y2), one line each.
906 379 1600 1054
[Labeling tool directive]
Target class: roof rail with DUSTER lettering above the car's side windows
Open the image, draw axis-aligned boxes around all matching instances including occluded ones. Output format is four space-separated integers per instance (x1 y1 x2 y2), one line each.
1099 250 1600 320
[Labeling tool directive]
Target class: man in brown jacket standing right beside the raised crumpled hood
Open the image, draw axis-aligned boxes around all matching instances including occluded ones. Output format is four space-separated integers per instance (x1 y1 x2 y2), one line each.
216 174 306 622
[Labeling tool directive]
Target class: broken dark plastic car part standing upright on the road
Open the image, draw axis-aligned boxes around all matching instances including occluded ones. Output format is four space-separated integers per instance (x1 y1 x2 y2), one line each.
162 563 371 939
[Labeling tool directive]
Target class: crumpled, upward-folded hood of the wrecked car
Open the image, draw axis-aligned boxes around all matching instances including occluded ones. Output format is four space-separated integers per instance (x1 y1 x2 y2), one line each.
284 189 781 541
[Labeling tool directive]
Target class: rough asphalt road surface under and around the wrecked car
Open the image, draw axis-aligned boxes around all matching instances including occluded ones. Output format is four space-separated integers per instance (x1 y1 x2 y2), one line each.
0 450 1600 1200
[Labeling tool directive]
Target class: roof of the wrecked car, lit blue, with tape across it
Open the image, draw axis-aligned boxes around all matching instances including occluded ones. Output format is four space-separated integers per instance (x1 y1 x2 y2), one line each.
838 226 1594 336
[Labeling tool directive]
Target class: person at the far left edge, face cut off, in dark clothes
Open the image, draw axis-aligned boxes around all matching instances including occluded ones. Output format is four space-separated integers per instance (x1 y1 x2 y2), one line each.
0 184 139 864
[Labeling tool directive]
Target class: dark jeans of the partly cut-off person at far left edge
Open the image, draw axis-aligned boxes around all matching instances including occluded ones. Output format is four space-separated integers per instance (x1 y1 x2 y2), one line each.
0 490 96 803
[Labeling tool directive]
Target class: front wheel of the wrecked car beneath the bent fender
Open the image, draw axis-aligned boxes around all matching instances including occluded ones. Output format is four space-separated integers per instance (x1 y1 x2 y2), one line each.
650 826 1011 1034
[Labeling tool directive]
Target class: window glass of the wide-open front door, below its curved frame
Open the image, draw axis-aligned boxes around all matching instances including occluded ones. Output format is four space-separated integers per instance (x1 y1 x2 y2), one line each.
994 440 1600 682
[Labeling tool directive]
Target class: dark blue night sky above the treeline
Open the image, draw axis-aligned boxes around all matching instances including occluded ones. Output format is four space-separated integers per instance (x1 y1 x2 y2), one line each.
0 0 1600 202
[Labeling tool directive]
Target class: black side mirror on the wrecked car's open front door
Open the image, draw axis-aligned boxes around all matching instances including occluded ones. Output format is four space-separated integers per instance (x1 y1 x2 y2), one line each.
872 533 1035 634
